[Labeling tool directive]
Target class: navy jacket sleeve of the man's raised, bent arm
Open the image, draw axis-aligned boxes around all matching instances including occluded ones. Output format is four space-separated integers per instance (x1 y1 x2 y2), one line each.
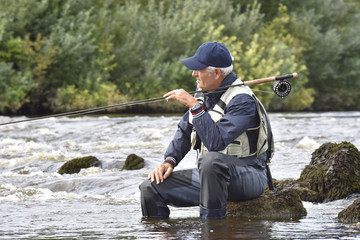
191 94 259 151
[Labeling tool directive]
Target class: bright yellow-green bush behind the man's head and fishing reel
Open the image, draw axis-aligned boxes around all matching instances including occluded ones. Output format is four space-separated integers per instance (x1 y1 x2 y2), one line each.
204 5 314 111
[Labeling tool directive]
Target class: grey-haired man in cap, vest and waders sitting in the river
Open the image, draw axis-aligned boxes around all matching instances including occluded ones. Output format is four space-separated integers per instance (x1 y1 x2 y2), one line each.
140 42 271 219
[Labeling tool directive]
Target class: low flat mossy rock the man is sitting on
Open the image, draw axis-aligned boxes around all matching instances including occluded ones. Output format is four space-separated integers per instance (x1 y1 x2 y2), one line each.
226 181 307 220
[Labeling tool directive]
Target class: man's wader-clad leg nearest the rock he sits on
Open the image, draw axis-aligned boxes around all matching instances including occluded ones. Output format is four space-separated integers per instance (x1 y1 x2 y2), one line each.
198 152 267 219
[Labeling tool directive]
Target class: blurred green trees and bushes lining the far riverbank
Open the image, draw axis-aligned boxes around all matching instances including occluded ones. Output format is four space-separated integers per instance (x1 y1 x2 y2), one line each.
0 0 360 115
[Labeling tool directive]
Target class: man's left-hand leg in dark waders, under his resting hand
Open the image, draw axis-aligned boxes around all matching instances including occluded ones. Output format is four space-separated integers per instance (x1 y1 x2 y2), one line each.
139 169 200 218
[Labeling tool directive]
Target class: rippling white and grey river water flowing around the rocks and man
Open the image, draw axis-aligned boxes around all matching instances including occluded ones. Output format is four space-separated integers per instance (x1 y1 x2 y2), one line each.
0 112 360 239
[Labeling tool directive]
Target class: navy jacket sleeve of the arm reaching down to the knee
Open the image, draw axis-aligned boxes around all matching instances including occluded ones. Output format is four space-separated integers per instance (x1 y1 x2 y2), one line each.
164 111 193 167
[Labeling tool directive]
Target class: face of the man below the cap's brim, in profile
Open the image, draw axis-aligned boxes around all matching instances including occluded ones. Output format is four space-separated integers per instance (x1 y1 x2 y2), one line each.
192 68 222 90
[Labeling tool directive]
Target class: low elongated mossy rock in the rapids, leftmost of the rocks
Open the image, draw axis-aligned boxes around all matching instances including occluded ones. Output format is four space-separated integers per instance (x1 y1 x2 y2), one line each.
58 156 102 174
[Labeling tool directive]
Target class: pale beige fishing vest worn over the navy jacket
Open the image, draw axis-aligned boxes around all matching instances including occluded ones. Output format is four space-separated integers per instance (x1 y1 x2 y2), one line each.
189 79 274 161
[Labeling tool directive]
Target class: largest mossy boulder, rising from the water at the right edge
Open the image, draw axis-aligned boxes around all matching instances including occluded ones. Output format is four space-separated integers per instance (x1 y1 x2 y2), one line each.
297 142 360 202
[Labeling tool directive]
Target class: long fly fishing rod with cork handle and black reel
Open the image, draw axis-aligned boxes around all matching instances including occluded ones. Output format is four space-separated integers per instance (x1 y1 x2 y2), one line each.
0 73 298 126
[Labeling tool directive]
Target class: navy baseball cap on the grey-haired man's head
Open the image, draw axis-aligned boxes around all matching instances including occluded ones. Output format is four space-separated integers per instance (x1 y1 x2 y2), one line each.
182 42 232 70
